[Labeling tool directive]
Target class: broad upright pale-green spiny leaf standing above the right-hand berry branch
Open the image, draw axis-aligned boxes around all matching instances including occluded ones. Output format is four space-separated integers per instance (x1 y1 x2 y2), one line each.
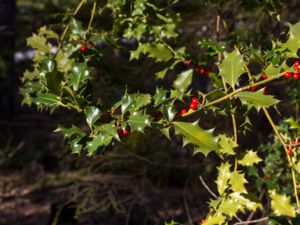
219 49 245 87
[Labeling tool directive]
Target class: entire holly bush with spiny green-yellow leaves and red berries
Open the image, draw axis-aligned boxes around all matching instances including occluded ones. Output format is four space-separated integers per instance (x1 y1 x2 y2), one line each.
20 0 300 225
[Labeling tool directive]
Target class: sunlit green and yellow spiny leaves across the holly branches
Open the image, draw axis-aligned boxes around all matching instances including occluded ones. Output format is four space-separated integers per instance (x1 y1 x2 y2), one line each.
21 0 300 224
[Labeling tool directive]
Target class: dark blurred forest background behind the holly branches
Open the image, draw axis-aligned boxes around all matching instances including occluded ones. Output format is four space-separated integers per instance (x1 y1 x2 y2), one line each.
0 0 300 225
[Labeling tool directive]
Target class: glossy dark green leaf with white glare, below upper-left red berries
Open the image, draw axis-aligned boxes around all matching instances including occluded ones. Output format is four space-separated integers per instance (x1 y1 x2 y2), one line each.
70 62 89 91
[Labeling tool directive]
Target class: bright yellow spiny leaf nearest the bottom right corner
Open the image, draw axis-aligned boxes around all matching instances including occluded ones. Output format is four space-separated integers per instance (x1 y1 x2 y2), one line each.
269 190 296 217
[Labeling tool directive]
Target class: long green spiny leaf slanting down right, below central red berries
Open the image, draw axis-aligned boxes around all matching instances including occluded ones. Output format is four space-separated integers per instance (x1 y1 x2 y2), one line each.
172 121 218 156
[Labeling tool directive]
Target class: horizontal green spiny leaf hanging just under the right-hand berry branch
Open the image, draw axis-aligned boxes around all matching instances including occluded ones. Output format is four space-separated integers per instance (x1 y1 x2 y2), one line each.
235 91 279 109
